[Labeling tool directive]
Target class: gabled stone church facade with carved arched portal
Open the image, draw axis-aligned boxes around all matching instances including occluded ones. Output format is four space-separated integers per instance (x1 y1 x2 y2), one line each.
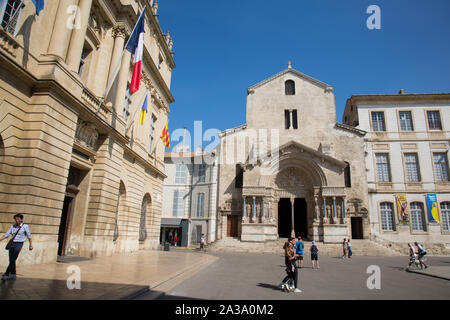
218 65 370 243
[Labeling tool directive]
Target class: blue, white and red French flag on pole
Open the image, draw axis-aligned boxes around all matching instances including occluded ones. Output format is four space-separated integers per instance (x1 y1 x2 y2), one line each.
126 8 145 93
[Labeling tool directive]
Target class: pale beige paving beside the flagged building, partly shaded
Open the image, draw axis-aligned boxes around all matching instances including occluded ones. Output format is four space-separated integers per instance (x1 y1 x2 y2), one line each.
0 250 217 300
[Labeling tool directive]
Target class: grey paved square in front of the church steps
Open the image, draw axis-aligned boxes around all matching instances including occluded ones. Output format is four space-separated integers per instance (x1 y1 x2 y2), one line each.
138 253 450 300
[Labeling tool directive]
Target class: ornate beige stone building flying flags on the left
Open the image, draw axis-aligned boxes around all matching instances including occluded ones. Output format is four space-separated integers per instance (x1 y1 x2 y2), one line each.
0 0 175 265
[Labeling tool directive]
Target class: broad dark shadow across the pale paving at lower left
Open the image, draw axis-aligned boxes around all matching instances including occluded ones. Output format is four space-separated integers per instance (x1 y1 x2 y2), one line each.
0 275 149 300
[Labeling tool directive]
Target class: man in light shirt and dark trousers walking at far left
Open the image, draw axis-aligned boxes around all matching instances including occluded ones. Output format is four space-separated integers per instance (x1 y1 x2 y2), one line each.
0 214 33 280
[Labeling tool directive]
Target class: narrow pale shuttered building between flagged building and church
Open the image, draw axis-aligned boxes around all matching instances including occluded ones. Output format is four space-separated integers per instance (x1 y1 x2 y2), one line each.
160 149 218 247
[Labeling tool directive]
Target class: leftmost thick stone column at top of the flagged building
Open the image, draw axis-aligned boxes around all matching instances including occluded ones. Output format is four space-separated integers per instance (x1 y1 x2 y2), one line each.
47 0 79 62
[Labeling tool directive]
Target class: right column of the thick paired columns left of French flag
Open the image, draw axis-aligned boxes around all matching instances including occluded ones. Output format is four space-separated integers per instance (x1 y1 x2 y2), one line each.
66 0 92 73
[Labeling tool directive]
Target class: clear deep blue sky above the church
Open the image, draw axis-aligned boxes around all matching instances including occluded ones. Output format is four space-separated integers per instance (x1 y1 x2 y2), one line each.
159 0 450 151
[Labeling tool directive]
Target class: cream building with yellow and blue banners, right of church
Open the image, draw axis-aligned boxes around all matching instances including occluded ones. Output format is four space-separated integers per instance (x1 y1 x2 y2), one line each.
343 90 450 253
